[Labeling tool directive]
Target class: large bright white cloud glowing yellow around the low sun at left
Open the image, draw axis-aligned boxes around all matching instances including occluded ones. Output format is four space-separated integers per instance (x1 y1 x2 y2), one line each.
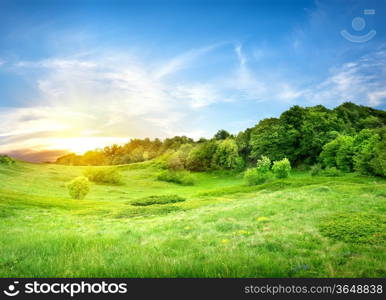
0 46 229 155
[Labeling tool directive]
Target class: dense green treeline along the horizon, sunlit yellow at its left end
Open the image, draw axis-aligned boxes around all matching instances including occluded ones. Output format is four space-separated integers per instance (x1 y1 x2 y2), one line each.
57 102 386 176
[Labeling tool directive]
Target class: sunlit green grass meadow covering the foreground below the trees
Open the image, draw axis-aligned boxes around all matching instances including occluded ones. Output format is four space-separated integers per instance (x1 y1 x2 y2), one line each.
0 162 386 277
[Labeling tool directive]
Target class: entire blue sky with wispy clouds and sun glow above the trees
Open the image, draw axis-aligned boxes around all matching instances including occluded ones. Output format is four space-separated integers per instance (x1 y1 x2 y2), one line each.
0 0 386 159
